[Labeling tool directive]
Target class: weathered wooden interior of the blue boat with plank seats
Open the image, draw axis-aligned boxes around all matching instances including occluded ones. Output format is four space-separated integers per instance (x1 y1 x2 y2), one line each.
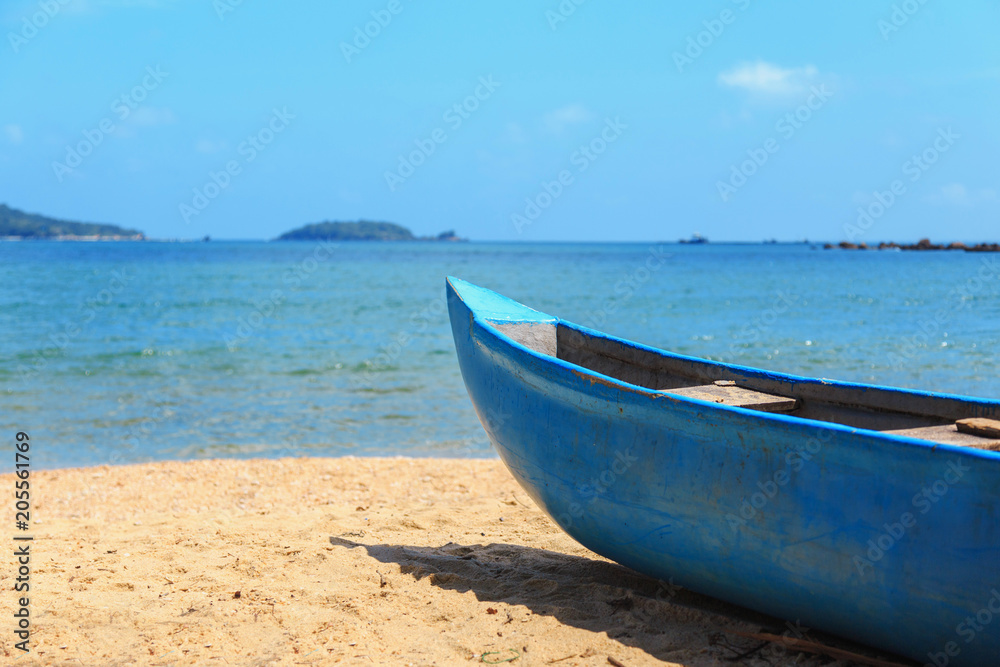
492 322 1000 451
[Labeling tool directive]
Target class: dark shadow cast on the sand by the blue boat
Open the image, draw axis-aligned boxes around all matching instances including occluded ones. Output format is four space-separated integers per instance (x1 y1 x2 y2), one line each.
330 537 916 666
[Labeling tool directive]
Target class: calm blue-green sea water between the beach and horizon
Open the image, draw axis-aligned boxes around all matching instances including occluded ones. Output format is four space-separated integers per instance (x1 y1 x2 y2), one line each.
0 242 1000 470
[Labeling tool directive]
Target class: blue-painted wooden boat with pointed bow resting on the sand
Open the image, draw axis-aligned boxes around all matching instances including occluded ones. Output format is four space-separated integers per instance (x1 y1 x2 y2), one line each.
447 278 1000 667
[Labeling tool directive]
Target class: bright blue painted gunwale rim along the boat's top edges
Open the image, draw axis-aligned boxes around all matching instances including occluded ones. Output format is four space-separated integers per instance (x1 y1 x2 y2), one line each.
447 276 1000 462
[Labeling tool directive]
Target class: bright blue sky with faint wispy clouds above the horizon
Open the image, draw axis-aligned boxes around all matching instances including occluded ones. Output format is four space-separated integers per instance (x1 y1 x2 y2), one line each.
0 0 1000 242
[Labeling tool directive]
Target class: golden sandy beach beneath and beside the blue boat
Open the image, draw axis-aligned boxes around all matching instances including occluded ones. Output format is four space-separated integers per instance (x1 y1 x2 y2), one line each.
0 458 904 667
